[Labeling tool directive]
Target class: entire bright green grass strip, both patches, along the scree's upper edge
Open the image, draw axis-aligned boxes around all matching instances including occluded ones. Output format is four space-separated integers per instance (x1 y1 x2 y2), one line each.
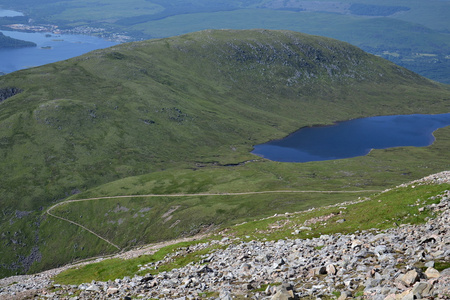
54 184 450 284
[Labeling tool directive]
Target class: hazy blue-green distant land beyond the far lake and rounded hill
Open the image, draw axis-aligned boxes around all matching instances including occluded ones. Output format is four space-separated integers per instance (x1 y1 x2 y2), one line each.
0 0 450 84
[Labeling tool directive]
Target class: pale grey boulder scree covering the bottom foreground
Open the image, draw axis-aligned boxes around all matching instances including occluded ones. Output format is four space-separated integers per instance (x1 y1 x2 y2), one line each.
0 171 450 300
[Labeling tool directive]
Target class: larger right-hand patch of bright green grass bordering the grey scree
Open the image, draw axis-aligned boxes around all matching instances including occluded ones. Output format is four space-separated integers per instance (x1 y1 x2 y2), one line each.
227 184 449 240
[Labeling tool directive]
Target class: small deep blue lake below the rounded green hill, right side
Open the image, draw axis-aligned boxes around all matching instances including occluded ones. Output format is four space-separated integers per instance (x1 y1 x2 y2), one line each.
252 113 450 162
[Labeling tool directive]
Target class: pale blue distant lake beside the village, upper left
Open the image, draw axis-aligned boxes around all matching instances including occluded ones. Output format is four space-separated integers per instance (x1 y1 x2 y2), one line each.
0 30 118 73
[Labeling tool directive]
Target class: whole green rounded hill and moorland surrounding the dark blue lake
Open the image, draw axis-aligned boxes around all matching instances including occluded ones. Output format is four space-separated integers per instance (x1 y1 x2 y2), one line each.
0 30 450 276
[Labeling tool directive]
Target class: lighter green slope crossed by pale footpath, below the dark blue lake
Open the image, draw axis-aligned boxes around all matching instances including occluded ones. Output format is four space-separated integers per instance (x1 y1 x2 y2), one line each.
31 128 450 267
